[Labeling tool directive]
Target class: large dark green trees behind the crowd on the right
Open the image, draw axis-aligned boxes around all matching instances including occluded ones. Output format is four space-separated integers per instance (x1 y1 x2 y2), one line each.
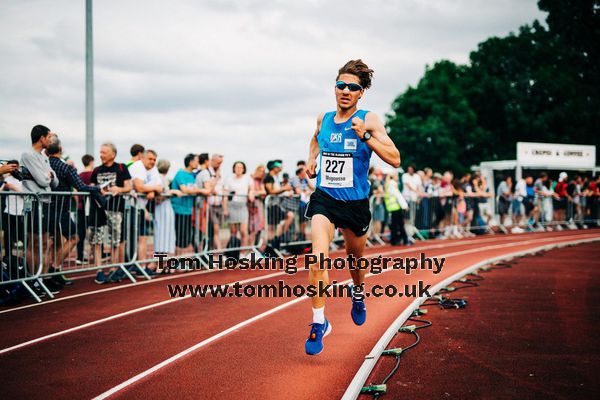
387 0 600 173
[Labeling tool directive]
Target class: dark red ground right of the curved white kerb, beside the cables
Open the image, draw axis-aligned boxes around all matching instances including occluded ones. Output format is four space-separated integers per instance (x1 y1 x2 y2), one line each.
360 243 600 400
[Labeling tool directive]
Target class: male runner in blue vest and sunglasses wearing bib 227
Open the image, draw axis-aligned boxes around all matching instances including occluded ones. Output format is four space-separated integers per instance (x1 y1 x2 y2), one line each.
305 60 400 355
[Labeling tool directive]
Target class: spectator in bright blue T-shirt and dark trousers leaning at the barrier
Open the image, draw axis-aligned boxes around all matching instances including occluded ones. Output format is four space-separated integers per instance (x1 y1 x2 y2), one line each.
171 153 207 254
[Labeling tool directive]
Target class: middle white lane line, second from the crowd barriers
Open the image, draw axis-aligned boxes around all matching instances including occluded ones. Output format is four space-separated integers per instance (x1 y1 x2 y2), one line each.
0 231 592 355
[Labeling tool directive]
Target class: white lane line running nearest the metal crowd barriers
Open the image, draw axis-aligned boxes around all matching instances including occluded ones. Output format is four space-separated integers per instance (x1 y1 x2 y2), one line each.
0 235 556 315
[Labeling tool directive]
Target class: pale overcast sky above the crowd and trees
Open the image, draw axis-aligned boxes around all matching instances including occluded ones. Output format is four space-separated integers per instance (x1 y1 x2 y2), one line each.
0 0 545 175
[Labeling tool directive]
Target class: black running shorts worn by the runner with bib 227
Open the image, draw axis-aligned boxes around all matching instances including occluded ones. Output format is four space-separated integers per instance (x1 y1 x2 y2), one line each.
305 189 371 236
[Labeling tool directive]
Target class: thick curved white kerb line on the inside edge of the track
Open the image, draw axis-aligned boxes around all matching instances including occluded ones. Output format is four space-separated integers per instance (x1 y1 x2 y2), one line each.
342 237 600 400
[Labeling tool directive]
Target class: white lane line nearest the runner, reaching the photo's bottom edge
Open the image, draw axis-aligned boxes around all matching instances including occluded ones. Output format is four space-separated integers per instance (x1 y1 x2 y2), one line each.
94 233 600 400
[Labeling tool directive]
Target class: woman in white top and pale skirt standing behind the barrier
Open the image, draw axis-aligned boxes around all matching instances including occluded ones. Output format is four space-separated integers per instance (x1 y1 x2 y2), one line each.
223 161 254 246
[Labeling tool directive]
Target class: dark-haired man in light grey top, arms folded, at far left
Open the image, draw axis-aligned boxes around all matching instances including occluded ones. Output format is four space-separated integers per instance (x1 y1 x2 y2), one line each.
21 125 61 293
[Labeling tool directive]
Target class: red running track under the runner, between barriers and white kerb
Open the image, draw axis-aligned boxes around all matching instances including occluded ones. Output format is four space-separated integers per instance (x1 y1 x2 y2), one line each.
0 230 600 399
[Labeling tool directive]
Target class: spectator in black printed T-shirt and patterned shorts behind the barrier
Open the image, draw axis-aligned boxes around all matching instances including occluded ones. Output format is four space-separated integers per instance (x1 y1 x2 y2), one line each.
90 142 131 284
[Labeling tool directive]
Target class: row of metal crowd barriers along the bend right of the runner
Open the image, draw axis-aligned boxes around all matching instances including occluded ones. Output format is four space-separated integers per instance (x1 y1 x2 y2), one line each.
370 195 600 244
